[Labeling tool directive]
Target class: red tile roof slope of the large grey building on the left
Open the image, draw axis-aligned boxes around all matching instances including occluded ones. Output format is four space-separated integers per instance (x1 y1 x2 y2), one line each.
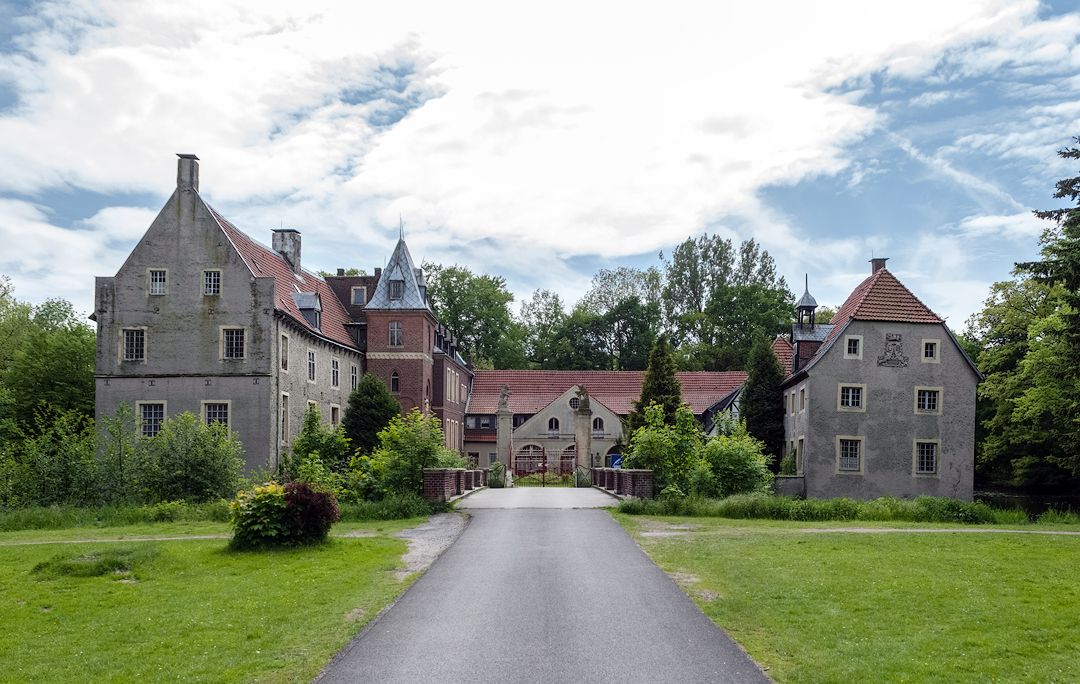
206 204 356 349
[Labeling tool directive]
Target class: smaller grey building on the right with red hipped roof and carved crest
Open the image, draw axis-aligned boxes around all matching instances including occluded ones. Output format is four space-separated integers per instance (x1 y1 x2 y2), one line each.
773 258 982 500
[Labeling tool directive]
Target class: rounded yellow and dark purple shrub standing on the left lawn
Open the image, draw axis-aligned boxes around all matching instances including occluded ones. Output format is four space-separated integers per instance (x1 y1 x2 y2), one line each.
229 482 340 549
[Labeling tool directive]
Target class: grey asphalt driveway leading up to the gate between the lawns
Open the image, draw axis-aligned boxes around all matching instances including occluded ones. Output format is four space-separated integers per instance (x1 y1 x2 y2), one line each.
320 489 769 683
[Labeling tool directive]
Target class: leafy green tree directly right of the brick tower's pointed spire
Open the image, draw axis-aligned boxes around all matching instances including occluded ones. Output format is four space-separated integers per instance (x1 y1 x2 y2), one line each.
423 263 525 368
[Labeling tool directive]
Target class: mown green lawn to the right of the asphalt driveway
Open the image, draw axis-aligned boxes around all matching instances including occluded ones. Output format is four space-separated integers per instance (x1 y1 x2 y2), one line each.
615 513 1080 683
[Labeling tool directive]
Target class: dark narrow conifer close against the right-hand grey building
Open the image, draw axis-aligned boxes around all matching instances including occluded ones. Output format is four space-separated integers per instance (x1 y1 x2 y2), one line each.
739 337 784 467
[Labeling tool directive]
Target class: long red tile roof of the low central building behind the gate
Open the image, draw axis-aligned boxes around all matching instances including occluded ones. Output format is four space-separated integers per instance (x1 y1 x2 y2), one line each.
469 371 746 415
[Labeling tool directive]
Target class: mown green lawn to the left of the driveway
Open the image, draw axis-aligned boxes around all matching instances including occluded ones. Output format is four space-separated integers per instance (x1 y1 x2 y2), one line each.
0 520 422 682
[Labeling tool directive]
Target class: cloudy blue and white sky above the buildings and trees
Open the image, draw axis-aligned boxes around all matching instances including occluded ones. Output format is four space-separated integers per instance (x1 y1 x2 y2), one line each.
0 0 1080 332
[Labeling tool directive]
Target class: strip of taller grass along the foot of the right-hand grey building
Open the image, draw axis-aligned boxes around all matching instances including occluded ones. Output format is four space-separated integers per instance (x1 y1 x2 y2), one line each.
619 494 1080 525
